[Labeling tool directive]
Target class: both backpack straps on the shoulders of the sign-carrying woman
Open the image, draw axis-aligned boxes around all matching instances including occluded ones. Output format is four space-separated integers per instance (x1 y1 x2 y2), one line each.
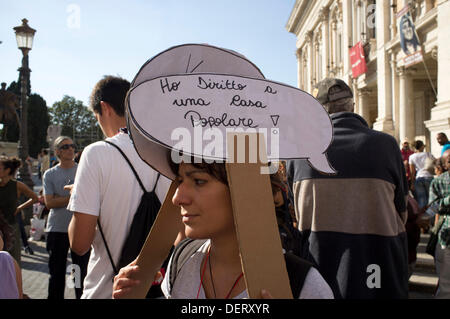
168 238 312 299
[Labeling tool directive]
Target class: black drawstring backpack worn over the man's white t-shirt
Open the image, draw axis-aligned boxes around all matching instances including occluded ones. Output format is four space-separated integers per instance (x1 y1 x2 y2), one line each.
97 141 161 275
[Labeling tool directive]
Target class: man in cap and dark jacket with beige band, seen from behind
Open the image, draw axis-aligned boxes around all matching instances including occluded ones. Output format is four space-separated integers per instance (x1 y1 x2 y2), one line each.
287 78 408 299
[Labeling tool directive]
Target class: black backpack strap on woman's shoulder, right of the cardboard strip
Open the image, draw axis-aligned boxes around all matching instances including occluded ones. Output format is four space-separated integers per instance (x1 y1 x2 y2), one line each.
284 252 313 299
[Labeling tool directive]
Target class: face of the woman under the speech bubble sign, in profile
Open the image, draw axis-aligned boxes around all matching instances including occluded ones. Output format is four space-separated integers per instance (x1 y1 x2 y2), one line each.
172 163 235 239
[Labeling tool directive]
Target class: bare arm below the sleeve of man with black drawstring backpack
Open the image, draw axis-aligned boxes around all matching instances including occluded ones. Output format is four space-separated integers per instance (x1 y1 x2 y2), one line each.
69 212 97 256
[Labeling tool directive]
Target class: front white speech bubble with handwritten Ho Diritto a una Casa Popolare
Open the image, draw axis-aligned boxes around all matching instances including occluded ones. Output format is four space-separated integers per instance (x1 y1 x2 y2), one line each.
128 73 335 178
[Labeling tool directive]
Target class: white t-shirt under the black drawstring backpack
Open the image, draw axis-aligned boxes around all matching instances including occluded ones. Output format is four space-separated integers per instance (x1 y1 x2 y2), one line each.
67 133 170 299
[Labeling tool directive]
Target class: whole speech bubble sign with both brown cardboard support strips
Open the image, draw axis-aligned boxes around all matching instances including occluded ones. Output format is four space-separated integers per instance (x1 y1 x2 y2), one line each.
126 44 333 298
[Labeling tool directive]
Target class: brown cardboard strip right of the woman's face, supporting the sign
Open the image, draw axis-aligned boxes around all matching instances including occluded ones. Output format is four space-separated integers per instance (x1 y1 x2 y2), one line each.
226 133 292 299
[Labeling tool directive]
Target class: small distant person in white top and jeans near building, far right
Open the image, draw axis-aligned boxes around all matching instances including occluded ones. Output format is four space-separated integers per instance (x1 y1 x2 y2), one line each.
409 140 434 208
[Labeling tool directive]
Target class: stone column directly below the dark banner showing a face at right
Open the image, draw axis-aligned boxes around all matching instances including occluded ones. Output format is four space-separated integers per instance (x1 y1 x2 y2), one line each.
398 67 416 142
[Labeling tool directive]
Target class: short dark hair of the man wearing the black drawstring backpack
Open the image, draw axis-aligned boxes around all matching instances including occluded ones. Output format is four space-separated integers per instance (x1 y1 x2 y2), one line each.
90 75 130 116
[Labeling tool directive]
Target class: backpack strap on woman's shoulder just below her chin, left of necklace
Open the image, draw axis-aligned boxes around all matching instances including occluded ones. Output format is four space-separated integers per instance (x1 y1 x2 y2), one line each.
168 238 207 290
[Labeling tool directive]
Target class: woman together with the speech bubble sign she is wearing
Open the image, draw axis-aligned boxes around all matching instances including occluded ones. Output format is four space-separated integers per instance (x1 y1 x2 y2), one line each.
113 44 333 299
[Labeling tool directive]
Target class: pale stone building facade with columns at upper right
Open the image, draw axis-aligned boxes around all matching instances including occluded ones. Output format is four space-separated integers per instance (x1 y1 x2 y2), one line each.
286 0 450 157
